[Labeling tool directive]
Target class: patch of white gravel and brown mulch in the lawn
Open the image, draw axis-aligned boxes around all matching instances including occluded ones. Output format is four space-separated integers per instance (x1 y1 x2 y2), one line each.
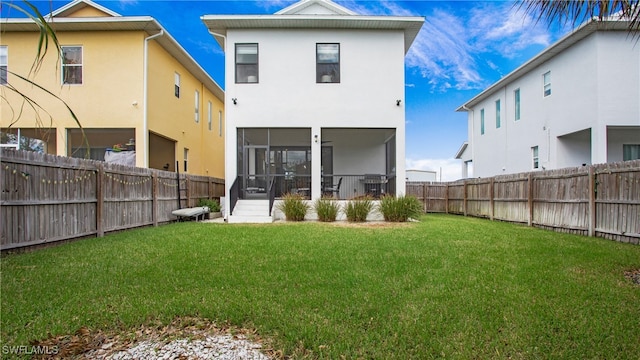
32 317 281 359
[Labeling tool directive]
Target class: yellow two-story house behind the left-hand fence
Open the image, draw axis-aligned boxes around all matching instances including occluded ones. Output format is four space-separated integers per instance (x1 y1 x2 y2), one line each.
0 0 224 178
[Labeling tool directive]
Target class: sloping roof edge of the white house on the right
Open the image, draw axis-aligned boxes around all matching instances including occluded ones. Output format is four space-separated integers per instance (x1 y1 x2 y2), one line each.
456 19 629 112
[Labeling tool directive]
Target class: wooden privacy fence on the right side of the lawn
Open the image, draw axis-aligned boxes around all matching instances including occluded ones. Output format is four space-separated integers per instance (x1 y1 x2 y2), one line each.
407 160 640 244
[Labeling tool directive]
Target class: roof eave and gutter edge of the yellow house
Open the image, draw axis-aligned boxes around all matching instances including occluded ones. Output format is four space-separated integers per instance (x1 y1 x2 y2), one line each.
0 16 224 103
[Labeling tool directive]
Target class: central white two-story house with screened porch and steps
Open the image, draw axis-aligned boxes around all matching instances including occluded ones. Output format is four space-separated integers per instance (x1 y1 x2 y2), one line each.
202 0 424 222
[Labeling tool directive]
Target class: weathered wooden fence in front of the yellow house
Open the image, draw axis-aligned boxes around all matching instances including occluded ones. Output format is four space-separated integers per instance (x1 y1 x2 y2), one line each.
0 149 224 250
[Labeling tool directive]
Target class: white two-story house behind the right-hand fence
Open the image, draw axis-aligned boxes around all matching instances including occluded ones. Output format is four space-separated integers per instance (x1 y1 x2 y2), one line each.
456 21 640 177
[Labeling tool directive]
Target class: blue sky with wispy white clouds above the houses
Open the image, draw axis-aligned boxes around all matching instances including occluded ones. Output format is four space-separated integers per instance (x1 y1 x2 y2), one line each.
8 0 571 181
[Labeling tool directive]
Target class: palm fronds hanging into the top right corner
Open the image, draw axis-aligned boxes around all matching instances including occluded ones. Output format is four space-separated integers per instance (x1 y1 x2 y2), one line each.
516 0 640 31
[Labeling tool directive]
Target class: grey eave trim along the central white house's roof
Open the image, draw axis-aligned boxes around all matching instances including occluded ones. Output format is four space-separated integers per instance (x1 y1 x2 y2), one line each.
201 15 424 53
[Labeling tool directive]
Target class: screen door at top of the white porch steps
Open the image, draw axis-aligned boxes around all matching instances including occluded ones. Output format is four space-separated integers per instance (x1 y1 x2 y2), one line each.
242 146 269 199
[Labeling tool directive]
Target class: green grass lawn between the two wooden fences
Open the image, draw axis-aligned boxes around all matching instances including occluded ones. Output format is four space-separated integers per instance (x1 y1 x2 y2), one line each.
0 215 640 359
